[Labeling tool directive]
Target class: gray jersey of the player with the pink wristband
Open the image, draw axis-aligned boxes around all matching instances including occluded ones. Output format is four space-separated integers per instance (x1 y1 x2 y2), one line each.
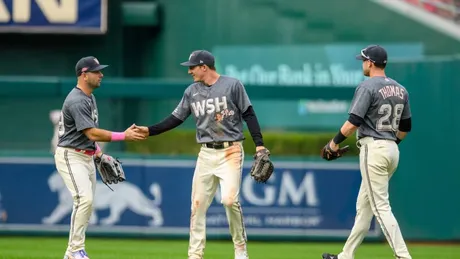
58 87 99 150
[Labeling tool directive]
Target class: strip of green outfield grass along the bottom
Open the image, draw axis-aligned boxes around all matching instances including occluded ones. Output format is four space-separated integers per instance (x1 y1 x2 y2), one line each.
0 237 460 259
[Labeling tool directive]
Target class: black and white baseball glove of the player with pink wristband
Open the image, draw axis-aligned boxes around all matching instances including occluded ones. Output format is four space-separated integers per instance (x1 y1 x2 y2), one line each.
94 154 126 188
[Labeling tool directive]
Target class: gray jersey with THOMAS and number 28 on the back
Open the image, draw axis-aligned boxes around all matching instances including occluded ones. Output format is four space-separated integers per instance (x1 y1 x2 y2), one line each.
349 77 411 140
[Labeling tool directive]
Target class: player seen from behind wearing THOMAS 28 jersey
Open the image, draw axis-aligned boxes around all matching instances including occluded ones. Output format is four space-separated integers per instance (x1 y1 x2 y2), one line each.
323 45 411 259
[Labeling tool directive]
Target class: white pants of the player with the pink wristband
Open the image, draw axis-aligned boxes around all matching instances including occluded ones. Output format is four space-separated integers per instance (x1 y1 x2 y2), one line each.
54 147 96 252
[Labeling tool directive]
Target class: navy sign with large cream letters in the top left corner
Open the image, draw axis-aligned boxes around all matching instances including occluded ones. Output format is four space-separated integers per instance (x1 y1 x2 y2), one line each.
0 0 108 34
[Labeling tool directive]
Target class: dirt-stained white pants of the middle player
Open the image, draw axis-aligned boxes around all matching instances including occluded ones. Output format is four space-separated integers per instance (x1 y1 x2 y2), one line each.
188 142 247 259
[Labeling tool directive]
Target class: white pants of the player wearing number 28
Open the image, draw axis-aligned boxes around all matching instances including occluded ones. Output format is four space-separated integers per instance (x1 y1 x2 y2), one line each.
339 137 411 259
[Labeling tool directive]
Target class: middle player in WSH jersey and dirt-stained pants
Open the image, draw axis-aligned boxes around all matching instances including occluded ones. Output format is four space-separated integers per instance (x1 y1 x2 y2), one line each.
135 50 265 259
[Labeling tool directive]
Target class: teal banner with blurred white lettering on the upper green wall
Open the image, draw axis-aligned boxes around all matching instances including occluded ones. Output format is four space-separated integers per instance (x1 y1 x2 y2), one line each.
213 43 424 87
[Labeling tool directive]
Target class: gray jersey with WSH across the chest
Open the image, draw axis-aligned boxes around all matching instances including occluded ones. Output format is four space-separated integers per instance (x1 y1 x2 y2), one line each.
172 76 251 143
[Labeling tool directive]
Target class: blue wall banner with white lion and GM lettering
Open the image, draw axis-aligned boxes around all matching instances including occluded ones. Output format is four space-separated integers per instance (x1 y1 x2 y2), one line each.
0 158 380 238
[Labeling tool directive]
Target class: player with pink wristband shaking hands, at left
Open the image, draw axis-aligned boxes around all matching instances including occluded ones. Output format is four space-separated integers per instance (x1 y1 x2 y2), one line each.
54 56 145 259
